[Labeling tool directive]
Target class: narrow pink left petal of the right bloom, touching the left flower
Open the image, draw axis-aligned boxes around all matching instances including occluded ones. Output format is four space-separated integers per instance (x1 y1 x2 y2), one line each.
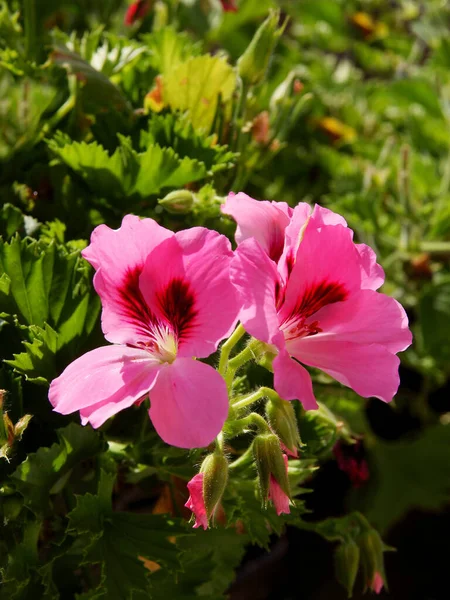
230 239 280 343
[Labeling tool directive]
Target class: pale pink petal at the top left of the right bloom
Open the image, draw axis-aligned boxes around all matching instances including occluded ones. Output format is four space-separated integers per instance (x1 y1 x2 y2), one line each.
222 192 292 262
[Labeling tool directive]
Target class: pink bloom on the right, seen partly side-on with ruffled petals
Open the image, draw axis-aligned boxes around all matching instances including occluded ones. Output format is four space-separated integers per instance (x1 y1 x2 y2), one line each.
222 193 411 409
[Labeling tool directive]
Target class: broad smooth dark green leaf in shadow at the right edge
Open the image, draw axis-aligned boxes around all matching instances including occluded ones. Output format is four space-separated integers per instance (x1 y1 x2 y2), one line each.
367 425 450 531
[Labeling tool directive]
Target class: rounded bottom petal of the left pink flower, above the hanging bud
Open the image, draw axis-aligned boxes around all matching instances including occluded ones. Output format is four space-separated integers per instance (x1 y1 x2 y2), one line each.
150 358 228 448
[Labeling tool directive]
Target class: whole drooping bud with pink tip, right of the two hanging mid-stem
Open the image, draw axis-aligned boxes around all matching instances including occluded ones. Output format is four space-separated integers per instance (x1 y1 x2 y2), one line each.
253 433 291 514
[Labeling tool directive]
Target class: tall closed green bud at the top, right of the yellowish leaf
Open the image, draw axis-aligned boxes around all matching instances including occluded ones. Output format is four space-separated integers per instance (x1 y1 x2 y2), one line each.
237 11 285 85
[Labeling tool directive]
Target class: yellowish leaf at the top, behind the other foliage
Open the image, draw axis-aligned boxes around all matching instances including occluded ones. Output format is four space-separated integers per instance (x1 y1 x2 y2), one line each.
163 54 236 133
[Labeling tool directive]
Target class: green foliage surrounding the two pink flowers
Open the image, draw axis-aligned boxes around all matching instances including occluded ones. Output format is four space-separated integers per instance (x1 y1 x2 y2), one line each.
0 0 450 600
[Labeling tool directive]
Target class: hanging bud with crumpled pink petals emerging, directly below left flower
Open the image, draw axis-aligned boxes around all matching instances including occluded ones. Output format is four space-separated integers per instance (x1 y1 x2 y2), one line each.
185 454 228 529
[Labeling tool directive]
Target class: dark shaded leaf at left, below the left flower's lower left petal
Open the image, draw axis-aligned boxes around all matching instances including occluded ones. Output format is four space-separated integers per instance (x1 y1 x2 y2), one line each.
11 423 105 514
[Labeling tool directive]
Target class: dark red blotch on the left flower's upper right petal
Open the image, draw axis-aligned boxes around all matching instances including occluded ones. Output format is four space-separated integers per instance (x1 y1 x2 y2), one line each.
158 278 198 342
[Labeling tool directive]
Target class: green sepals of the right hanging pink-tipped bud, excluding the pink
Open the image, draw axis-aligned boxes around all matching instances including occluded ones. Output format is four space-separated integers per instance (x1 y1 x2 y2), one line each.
253 433 291 507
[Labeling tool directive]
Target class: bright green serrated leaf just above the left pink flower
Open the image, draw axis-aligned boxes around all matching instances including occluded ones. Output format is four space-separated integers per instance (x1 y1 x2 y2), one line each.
49 136 207 207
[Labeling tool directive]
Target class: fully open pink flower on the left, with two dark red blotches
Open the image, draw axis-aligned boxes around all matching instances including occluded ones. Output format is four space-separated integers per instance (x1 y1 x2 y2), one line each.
49 215 238 448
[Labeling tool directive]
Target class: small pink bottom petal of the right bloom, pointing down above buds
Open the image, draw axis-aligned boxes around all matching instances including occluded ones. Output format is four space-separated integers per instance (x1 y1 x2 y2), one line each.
273 350 318 410
